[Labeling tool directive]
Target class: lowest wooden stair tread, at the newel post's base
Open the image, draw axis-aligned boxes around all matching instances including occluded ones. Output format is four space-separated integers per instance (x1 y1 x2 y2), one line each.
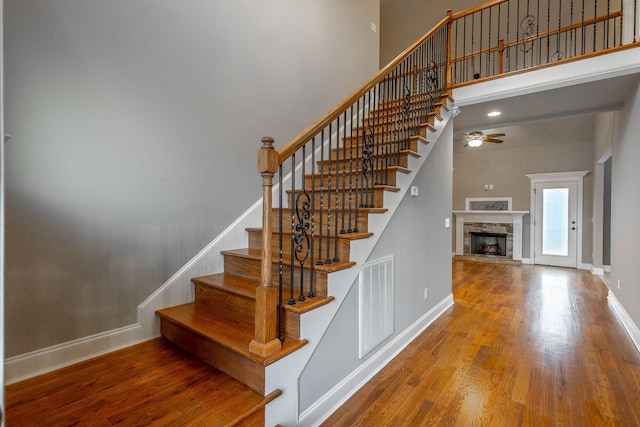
156 302 307 366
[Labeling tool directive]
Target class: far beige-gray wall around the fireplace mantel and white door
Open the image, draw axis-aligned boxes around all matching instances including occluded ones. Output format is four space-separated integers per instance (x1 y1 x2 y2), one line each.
453 113 594 263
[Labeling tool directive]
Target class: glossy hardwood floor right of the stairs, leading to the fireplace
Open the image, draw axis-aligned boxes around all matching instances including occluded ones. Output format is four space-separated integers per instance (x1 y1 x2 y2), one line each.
323 261 640 427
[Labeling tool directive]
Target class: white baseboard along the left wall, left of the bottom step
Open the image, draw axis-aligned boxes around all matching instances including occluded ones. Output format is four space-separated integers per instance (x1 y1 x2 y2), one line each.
4 324 148 384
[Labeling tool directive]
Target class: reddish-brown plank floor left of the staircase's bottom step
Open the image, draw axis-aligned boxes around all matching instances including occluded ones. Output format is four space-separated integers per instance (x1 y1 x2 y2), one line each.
6 338 279 427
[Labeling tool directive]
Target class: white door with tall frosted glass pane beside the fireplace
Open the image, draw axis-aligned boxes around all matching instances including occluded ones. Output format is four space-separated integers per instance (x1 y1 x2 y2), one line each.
533 181 581 268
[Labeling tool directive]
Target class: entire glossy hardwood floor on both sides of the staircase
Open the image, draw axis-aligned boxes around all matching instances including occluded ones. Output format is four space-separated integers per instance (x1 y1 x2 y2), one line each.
6 261 640 427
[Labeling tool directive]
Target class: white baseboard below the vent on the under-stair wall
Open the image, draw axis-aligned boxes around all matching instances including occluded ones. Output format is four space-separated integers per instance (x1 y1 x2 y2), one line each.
299 294 453 426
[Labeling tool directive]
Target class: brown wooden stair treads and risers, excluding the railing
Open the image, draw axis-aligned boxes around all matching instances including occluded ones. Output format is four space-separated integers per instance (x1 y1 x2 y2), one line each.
157 93 452 394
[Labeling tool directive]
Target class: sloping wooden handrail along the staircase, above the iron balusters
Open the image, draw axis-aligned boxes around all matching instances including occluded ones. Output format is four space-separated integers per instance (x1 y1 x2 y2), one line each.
278 15 451 164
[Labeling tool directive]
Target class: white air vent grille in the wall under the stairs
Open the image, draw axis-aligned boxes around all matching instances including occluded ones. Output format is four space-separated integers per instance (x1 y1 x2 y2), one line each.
359 256 393 358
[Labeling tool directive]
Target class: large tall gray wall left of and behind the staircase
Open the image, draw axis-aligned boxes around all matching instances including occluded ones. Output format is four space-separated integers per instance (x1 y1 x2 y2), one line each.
5 0 379 356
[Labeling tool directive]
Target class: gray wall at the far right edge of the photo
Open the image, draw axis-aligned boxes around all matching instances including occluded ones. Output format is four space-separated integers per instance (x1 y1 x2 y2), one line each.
609 85 640 332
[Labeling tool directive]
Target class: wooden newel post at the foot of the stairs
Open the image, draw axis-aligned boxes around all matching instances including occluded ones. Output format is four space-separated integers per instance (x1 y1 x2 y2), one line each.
249 136 282 356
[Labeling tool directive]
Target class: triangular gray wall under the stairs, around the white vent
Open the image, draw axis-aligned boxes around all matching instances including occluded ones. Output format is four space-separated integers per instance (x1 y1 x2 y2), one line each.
300 122 452 412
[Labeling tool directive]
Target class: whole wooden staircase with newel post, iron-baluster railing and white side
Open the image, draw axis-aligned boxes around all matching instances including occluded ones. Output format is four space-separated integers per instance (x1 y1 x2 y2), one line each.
151 0 635 424
